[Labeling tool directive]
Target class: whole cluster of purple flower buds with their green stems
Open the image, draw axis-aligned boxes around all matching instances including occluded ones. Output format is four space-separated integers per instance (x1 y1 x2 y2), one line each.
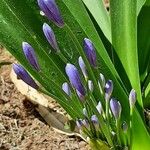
13 0 136 147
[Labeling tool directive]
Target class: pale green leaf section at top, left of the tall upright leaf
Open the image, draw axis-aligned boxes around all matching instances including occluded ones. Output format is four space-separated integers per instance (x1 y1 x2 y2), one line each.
82 0 111 42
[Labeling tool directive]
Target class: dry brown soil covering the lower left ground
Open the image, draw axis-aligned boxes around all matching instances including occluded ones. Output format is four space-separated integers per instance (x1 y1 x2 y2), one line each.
0 49 89 150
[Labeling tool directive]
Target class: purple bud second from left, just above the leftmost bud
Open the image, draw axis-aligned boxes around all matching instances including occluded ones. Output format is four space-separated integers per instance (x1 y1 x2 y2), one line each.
22 42 40 71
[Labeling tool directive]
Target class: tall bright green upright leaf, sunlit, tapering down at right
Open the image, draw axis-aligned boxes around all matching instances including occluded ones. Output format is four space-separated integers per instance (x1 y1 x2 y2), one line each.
110 0 143 107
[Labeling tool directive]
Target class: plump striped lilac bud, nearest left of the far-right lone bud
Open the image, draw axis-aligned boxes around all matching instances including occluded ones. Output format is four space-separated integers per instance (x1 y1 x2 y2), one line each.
110 98 122 120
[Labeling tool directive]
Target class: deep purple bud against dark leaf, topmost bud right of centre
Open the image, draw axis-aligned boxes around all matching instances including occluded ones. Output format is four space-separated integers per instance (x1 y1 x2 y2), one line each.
84 38 97 67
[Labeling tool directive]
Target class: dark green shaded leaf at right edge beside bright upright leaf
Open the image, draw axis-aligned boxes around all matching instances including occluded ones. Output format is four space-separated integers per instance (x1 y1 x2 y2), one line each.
137 6 150 82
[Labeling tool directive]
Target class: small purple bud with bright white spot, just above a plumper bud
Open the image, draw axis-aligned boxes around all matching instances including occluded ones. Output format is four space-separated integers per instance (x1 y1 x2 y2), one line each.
105 80 113 101
